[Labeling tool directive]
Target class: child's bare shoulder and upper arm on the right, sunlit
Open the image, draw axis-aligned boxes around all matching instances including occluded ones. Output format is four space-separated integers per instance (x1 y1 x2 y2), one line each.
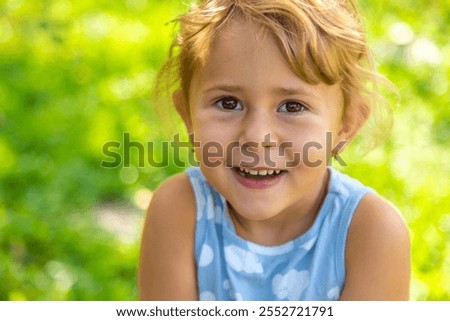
342 193 410 300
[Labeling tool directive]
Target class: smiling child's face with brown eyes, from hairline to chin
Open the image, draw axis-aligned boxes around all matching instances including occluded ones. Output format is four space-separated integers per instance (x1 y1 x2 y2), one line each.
179 18 345 221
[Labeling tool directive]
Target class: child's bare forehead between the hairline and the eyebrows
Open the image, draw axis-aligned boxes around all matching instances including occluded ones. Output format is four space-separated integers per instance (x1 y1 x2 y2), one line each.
190 18 341 106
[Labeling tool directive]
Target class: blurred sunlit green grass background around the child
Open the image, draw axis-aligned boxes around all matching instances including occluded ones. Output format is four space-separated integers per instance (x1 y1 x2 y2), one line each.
0 0 450 300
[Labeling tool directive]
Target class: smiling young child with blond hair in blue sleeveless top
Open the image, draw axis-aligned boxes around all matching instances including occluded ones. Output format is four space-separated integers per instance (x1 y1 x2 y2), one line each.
139 0 410 300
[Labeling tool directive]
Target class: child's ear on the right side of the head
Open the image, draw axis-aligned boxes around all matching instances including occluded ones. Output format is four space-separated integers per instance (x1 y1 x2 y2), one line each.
337 96 370 153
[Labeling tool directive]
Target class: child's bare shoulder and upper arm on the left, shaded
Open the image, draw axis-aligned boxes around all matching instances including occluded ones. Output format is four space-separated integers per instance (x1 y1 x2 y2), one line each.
138 174 197 301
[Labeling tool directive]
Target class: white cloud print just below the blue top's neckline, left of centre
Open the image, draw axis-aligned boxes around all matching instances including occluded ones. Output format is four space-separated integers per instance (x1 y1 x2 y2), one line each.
225 245 264 274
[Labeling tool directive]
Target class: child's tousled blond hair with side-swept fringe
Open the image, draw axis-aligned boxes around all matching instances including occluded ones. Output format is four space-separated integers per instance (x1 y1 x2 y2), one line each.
153 0 394 148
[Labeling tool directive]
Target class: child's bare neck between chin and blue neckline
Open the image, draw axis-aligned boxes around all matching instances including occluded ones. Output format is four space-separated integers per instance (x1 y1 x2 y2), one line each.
227 170 330 246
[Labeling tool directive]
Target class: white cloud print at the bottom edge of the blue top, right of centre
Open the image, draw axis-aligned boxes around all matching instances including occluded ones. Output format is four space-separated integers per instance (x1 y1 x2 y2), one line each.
272 269 309 301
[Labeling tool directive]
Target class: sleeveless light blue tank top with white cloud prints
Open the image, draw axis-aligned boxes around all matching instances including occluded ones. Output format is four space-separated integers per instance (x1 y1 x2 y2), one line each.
186 167 373 301
